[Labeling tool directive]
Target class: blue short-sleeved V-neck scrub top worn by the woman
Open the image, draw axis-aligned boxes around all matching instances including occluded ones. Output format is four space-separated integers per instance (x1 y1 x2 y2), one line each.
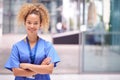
5 38 60 80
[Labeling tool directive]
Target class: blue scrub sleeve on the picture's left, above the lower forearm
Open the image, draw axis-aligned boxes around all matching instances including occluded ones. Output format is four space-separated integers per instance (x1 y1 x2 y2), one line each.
5 45 20 71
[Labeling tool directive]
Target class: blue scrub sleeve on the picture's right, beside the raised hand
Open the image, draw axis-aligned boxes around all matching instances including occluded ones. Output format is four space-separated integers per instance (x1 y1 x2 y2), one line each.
45 42 60 67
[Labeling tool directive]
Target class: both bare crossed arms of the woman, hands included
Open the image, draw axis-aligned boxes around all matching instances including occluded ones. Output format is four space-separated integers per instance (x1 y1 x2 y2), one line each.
12 58 54 77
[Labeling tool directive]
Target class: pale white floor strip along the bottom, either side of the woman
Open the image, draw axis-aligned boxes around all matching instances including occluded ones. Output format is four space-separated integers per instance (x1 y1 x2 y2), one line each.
0 74 120 80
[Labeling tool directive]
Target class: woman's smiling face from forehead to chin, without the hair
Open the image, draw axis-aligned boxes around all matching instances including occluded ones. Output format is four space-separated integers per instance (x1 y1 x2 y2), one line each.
25 14 40 35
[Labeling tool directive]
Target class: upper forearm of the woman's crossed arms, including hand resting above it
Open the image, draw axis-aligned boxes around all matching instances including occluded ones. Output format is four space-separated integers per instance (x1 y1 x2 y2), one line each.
20 58 54 74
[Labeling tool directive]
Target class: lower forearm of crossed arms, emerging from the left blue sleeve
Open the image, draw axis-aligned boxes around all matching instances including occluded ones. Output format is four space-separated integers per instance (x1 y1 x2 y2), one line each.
12 68 36 77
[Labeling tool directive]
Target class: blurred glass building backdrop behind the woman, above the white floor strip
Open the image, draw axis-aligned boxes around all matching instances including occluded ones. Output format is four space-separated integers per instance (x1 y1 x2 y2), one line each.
0 0 120 80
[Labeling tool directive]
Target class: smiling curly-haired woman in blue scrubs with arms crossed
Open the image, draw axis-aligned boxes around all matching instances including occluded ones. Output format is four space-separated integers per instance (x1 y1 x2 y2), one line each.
5 3 60 80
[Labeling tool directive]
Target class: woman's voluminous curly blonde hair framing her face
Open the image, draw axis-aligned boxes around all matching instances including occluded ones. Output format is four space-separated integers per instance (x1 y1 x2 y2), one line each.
17 3 49 30
